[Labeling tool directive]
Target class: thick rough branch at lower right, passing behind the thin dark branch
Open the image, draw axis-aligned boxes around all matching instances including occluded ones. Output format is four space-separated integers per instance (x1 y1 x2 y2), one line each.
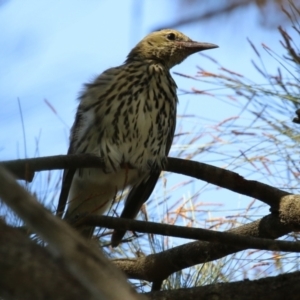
113 215 291 282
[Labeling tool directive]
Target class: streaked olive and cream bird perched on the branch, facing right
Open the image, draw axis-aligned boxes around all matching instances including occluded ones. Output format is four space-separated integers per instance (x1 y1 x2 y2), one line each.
57 29 218 247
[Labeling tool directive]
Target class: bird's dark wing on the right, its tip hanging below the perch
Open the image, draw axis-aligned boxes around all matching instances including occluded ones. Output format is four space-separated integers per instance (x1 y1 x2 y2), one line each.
111 102 176 247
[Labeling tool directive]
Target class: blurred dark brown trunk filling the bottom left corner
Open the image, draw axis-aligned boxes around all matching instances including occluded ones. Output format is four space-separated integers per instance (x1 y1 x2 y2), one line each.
0 219 95 300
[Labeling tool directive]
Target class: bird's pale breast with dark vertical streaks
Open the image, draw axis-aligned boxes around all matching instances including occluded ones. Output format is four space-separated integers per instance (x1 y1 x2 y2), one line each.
76 63 177 172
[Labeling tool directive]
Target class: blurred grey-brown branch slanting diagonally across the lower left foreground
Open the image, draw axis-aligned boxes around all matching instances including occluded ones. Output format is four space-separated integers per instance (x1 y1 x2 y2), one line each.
0 166 142 300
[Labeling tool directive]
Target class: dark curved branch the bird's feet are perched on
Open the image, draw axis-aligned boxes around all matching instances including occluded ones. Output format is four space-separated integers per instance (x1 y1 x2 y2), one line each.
1 155 289 211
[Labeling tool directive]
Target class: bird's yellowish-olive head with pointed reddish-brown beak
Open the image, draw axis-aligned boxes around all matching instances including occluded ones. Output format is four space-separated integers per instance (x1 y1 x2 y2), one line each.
126 29 218 69
